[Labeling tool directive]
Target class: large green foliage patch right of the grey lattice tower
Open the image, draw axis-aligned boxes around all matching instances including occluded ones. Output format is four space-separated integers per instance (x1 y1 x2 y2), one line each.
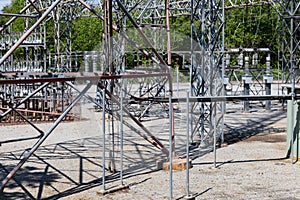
225 5 278 50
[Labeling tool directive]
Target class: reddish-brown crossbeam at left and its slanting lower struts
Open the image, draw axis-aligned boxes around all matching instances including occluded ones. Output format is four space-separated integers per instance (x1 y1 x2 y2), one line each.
0 73 169 191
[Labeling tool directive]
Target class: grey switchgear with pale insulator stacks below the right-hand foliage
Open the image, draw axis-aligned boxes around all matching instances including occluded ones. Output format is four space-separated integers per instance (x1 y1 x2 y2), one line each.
225 47 273 112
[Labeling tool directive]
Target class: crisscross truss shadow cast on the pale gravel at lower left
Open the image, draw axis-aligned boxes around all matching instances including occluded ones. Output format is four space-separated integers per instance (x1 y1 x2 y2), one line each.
0 137 162 200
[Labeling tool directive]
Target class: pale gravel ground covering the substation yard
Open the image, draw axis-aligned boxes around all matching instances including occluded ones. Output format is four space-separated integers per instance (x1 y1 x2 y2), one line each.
0 99 300 200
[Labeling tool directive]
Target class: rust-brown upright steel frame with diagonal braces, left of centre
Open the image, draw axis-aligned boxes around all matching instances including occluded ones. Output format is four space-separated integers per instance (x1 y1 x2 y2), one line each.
94 0 175 174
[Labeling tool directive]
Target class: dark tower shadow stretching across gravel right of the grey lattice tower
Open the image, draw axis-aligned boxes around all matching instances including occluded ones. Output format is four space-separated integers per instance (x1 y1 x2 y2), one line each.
180 111 286 164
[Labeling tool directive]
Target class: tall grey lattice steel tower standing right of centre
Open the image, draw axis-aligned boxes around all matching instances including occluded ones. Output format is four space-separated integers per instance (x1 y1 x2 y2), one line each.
190 0 225 146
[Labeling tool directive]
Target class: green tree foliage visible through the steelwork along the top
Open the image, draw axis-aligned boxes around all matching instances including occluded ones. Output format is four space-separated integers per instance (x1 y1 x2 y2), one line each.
0 0 280 72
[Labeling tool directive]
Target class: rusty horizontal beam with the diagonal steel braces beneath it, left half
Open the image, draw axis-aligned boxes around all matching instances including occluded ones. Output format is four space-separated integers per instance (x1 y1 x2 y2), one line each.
0 73 169 191
